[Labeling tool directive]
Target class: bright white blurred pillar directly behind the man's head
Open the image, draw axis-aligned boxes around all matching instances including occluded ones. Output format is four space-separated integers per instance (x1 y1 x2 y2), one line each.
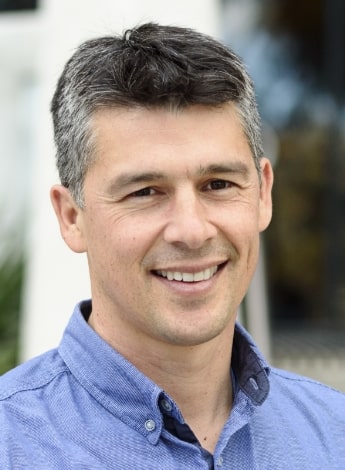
21 0 220 360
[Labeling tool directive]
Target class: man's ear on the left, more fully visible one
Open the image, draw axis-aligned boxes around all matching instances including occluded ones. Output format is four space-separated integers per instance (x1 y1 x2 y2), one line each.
50 185 86 253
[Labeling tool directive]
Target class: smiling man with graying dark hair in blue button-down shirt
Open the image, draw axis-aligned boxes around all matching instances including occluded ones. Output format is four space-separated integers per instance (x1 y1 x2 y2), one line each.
0 24 345 470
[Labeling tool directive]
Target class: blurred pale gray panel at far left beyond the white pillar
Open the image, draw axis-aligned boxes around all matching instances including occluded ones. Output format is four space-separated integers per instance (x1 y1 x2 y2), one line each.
0 14 37 261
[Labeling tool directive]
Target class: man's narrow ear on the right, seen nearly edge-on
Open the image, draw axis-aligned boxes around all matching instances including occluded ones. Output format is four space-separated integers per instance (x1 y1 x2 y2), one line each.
259 158 273 232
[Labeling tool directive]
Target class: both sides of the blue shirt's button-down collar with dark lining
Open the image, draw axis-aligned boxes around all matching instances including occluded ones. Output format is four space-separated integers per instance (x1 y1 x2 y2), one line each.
59 300 269 444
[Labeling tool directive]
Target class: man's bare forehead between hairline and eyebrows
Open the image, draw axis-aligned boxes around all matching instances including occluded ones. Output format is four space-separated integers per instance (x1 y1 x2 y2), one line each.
88 103 253 176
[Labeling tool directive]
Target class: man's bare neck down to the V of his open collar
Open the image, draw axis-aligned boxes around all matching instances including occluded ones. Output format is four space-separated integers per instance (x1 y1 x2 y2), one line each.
146 340 233 453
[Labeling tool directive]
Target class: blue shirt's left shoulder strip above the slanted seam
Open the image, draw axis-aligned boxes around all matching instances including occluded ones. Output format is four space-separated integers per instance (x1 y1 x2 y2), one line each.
0 349 68 402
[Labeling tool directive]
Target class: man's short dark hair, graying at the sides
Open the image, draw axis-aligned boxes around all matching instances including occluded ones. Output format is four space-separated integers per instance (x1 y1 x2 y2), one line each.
51 23 263 207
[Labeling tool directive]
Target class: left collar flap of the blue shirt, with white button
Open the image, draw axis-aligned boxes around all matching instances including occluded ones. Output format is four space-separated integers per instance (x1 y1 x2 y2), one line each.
59 301 163 444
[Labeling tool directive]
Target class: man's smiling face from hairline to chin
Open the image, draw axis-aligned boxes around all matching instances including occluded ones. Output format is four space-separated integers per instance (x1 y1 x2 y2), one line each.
61 105 272 345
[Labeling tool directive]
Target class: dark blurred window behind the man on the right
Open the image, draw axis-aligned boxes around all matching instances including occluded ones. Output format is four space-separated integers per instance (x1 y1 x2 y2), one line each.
222 0 345 389
